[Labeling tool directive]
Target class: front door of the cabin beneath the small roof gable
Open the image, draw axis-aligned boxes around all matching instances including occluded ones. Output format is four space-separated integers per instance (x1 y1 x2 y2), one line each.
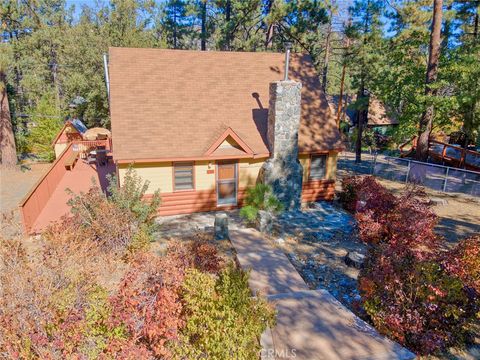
217 161 238 206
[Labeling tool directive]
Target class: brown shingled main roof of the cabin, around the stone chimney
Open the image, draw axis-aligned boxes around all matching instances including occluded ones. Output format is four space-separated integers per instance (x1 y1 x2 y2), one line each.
109 48 342 160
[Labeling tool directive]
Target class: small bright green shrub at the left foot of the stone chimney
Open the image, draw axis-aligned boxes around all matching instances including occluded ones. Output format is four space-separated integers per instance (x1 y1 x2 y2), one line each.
240 184 284 223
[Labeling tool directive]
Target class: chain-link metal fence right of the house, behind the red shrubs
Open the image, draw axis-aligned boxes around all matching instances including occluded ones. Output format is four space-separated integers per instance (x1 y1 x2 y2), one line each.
338 155 480 196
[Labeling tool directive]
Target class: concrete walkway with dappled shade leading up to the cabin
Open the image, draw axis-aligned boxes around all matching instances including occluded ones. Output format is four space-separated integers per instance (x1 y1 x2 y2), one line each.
230 229 415 360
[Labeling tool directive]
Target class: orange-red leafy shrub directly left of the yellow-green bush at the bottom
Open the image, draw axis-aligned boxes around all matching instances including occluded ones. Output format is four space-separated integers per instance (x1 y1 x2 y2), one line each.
110 254 185 357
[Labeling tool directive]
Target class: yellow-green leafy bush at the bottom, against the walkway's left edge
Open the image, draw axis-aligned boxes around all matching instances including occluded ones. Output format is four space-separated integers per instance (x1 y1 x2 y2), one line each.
176 264 274 359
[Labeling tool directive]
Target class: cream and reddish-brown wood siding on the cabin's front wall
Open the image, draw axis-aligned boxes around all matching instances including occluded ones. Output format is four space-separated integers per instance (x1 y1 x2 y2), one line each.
118 153 337 216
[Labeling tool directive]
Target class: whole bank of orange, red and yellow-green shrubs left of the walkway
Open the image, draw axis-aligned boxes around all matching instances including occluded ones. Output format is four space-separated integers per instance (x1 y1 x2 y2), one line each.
0 212 273 359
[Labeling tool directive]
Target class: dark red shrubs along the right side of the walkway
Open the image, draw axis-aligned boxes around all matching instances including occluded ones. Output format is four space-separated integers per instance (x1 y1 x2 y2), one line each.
351 177 479 354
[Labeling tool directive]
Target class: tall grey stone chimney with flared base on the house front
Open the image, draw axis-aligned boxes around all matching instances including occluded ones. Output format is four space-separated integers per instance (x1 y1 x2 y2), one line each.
262 80 303 210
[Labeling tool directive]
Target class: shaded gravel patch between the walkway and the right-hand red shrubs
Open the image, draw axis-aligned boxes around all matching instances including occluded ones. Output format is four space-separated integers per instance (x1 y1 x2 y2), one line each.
271 202 365 309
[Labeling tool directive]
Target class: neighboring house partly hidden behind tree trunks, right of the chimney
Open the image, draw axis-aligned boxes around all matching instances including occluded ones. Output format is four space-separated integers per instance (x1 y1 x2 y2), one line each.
327 94 399 134
